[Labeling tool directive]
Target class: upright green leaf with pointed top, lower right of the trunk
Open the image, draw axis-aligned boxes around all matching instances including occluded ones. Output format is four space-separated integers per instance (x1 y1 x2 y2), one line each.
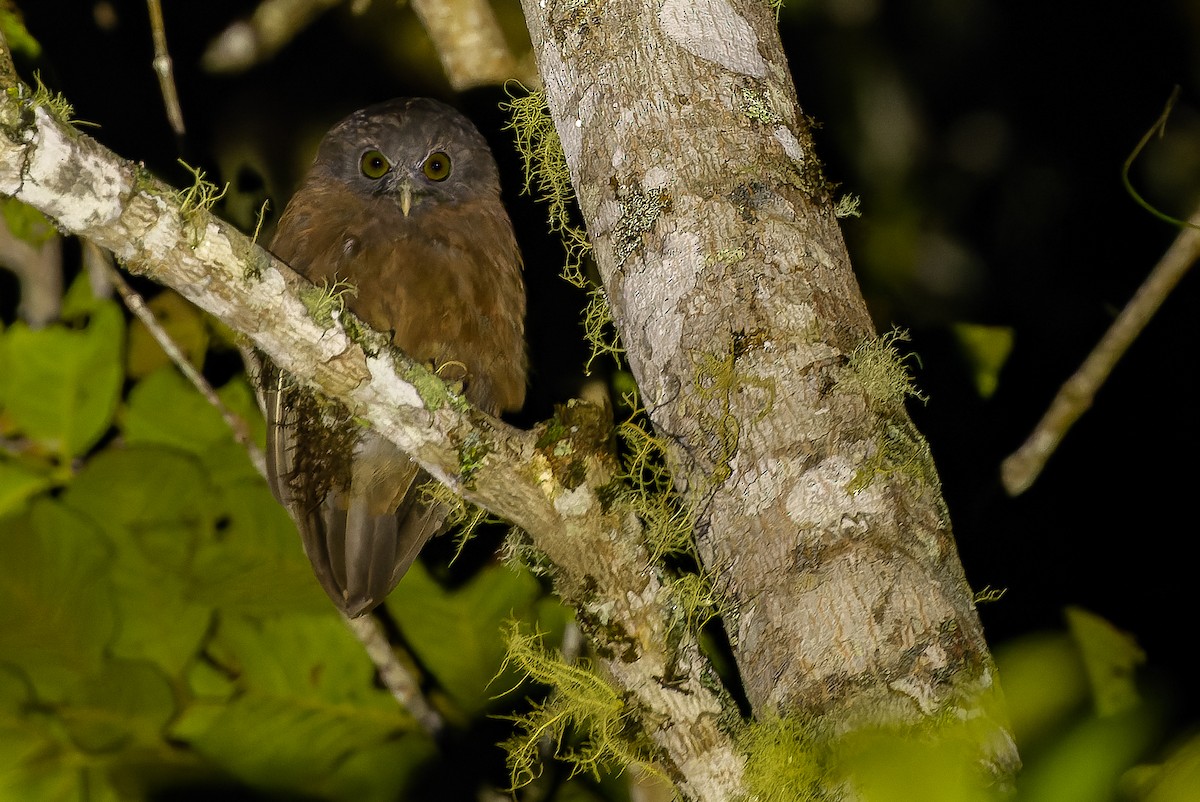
1067 606 1146 716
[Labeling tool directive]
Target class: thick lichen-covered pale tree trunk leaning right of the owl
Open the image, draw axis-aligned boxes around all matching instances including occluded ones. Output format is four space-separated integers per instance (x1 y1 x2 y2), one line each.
524 0 1015 777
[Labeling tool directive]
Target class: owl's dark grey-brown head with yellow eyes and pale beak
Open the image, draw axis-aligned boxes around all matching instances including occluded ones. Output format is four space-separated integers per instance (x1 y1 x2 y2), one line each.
310 97 500 216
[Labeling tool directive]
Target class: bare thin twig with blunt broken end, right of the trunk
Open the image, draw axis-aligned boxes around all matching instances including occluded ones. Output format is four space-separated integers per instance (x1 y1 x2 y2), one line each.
1000 199 1200 496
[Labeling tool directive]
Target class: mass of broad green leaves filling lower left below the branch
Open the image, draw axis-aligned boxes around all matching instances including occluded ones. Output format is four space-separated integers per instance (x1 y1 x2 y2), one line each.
0 273 564 802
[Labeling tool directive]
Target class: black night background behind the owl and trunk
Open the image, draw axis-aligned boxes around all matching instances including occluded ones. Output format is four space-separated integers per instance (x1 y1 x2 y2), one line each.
9 0 1200 744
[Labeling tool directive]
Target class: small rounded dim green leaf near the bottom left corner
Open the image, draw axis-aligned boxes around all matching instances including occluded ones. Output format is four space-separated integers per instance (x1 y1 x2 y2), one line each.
58 660 175 754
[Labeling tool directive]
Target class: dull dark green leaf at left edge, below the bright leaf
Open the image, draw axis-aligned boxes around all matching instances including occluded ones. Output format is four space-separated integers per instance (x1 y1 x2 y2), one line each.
0 498 114 700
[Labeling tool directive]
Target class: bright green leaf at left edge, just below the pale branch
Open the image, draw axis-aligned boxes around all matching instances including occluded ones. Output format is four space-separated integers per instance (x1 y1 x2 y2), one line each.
0 301 125 460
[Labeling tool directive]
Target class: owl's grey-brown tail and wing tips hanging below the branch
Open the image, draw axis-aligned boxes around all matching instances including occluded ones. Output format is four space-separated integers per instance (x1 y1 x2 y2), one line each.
263 360 446 617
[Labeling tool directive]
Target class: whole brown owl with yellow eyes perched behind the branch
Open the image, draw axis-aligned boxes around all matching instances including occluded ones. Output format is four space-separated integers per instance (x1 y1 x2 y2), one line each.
263 98 526 616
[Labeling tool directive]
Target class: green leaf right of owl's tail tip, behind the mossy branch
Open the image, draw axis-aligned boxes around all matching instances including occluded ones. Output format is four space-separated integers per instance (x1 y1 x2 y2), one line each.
386 562 541 713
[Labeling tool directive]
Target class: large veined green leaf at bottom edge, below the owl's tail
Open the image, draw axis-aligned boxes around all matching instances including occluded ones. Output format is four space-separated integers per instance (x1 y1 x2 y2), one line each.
172 609 413 800
